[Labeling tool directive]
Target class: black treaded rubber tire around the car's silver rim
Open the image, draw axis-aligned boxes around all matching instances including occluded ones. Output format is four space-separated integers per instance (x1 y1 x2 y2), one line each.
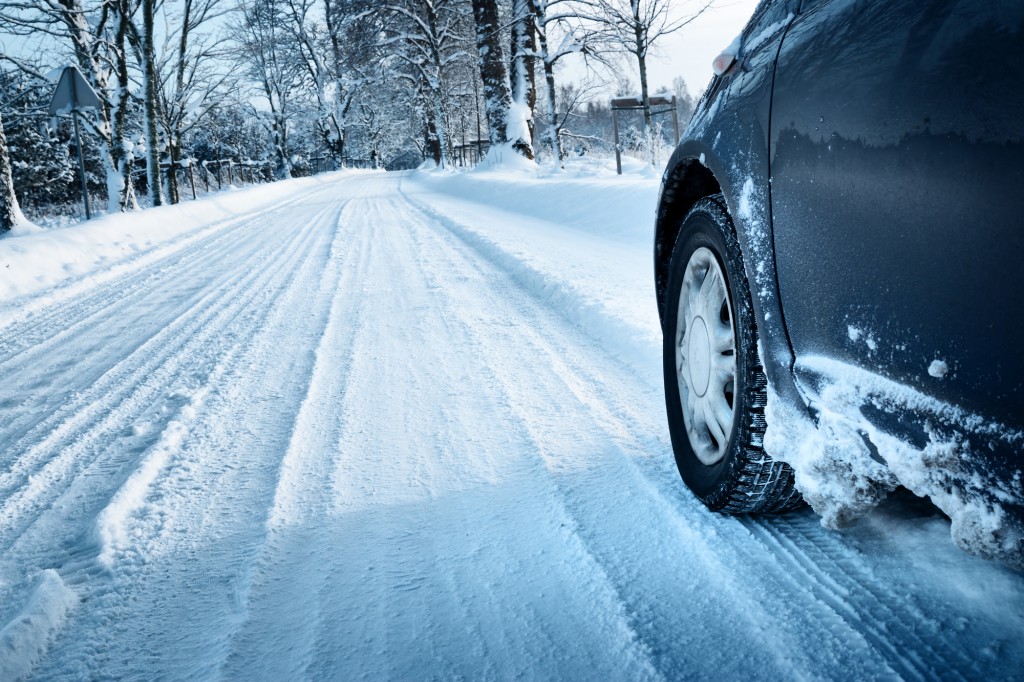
664 195 803 514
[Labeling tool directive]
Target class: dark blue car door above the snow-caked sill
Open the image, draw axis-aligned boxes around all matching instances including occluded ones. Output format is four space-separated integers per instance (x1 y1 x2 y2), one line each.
769 0 1024 424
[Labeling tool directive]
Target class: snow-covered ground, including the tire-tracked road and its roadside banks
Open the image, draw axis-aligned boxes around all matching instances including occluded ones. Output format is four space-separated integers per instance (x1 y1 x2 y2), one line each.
0 165 1024 680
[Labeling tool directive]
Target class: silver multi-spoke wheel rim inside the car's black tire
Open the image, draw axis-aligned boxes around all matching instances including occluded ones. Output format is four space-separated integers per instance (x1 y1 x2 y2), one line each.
675 247 736 466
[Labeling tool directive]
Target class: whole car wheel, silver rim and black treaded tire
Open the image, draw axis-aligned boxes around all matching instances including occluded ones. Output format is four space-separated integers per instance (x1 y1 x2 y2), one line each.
664 195 802 514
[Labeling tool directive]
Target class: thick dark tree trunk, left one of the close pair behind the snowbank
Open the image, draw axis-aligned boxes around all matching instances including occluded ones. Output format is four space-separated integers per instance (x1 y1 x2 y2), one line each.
473 0 512 147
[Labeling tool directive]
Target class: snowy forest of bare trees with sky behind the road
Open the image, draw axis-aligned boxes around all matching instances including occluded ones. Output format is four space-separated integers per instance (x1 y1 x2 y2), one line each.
0 0 711 227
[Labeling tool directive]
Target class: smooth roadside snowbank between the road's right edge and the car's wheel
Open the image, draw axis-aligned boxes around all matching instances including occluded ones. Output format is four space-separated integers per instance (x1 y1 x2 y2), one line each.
402 163 662 383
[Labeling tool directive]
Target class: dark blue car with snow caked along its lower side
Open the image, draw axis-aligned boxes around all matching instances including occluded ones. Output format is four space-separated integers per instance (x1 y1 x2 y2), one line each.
654 0 1024 566
